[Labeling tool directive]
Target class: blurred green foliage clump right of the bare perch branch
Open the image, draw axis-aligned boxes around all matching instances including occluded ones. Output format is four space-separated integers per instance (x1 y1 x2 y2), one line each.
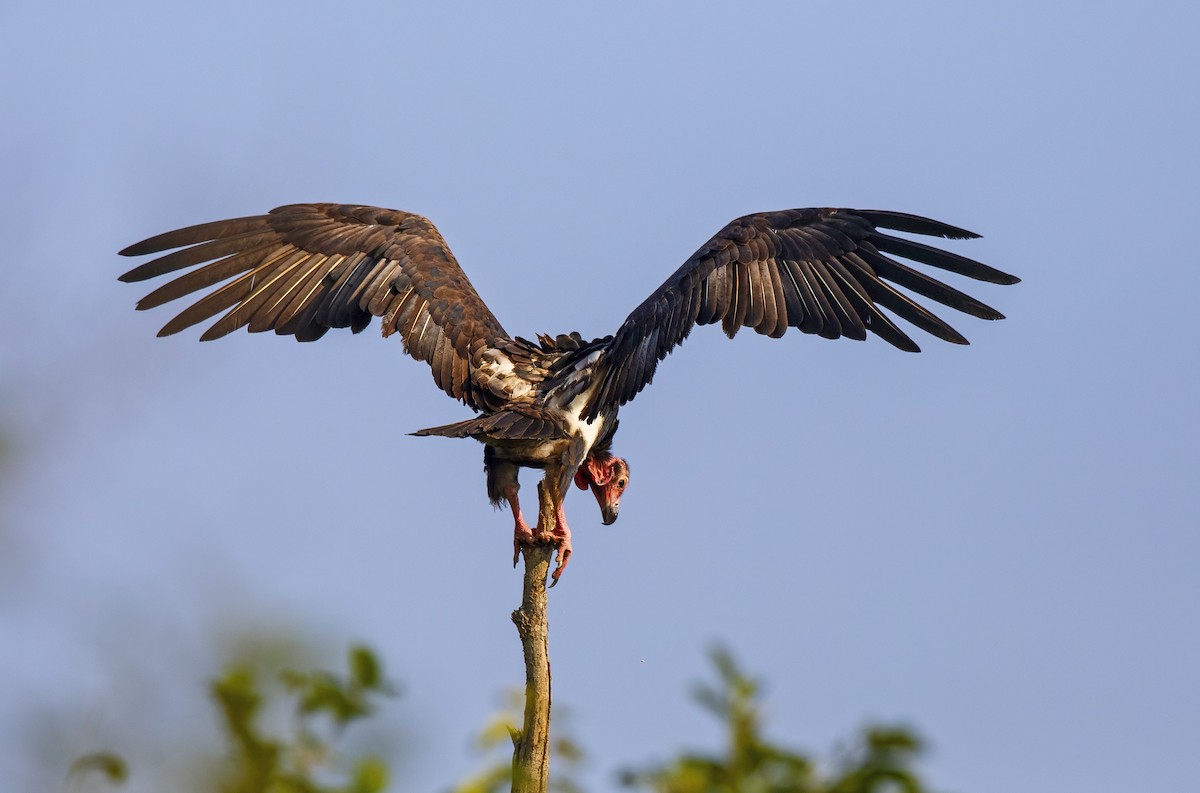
620 648 929 793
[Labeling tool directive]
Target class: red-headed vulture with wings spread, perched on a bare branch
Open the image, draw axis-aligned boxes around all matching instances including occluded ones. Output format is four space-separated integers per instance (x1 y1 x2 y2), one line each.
120 204 1019 584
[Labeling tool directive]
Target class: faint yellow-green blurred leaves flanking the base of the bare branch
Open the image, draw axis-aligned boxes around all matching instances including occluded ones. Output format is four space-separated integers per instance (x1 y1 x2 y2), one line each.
449 690 583 793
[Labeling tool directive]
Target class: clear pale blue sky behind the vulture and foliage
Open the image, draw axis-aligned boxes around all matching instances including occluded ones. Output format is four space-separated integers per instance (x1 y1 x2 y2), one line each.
0 2 1200 793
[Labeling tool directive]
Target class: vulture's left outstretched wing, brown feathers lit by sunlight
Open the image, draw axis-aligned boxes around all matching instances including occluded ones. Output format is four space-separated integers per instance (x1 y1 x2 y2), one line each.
121 204 508 409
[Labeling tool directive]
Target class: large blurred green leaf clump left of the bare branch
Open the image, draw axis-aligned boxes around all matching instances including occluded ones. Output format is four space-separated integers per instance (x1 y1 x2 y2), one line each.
211 647 392 793
